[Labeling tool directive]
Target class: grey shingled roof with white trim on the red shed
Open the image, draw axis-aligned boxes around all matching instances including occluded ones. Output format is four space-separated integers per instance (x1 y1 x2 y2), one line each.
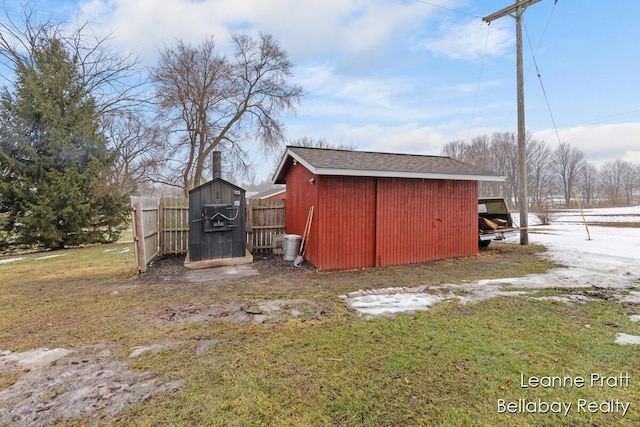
273 146 506 184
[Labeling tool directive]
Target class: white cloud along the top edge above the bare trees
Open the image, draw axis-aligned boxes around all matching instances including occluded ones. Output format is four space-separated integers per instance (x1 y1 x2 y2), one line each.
74 0 432 64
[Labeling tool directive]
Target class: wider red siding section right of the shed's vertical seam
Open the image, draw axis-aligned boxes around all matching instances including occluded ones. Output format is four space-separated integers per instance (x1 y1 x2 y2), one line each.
376 178 478 266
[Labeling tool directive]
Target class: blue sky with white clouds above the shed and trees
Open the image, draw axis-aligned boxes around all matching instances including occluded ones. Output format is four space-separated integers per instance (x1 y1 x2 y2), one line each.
4 0 640 179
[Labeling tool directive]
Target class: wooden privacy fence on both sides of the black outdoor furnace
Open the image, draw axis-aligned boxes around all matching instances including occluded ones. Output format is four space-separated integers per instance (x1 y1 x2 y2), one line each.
131 197 285 272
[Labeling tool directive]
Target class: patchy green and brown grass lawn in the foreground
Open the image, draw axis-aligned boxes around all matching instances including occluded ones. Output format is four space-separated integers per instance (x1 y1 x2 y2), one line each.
0 243 640 426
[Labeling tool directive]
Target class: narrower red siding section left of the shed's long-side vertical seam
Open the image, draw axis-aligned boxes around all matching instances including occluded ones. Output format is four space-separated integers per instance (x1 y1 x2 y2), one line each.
318 176 376 270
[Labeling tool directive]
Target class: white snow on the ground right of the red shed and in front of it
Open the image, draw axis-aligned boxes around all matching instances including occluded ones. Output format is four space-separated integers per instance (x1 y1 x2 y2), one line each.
343 206 640 316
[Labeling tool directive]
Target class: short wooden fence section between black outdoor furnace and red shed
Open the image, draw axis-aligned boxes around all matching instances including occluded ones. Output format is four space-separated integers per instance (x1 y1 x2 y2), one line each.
247 199 285 253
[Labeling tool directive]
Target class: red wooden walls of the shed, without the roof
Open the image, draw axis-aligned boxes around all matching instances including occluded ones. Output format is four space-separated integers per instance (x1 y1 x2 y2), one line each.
285 164 478 270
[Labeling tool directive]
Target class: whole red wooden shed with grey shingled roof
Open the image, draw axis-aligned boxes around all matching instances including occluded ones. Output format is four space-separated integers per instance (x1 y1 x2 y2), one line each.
273 147 505 270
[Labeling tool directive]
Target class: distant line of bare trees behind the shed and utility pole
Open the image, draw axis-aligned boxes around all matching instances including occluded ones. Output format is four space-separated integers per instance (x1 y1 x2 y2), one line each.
442 132 640 210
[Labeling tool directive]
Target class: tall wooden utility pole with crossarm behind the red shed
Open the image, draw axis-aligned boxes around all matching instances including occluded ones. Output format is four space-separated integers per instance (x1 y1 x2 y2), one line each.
482 0 540 245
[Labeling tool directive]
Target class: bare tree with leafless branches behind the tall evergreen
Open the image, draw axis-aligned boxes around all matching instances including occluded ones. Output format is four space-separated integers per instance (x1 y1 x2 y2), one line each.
0 3 144 194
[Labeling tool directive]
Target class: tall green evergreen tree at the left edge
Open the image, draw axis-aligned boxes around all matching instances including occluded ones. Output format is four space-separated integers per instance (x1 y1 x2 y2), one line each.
0 36 127 248
